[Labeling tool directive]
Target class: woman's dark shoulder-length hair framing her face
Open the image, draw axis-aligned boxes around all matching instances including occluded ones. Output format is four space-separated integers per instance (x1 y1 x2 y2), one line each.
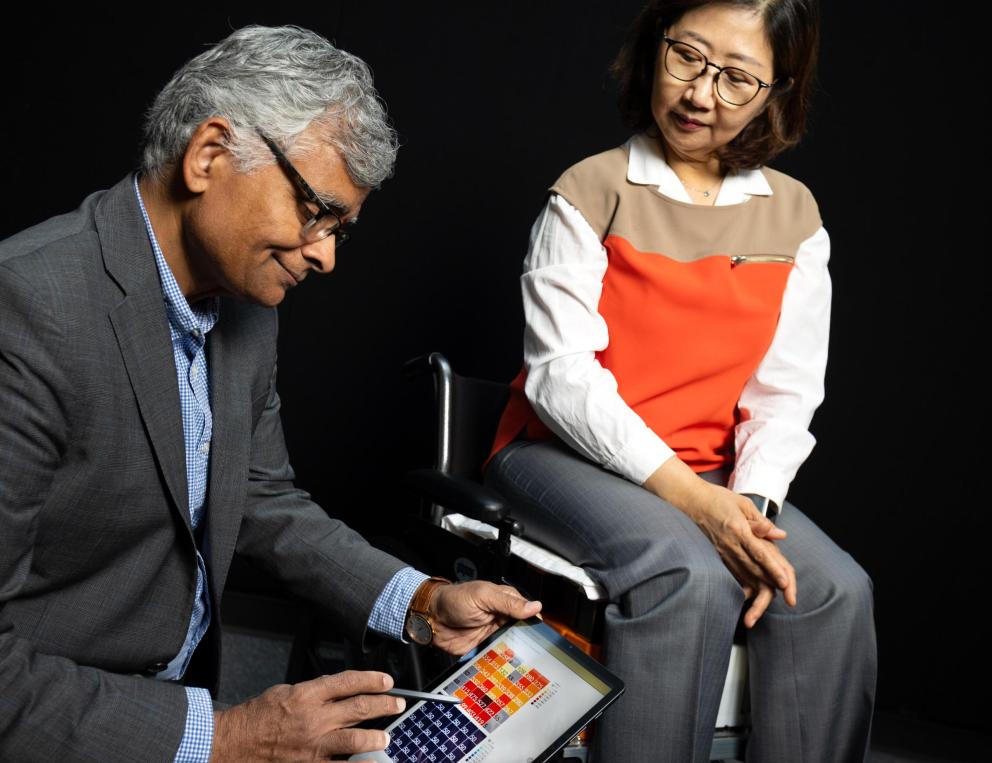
610 0 820 172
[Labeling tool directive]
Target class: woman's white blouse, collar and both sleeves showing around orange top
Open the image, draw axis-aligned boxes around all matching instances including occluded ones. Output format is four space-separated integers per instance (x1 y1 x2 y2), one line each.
521 135 831 511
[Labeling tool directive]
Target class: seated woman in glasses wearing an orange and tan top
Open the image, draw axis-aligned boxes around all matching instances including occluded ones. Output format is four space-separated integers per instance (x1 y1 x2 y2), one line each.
487 0 876 763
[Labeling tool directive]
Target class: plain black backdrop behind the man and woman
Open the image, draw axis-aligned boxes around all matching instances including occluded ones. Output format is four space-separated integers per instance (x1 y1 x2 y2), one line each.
0 0 990 728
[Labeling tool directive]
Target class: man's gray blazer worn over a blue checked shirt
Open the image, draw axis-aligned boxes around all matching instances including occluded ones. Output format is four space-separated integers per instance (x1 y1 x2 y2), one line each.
0 177 402 763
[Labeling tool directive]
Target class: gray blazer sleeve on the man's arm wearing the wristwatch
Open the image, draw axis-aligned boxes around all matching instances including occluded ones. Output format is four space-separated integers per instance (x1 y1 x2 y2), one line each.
237 354 406 643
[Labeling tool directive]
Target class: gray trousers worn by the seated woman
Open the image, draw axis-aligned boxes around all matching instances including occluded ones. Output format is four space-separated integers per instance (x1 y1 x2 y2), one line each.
486 441 877 763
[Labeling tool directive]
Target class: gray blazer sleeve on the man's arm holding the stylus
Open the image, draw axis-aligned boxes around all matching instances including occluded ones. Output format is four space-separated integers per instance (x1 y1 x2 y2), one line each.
0 264 186 763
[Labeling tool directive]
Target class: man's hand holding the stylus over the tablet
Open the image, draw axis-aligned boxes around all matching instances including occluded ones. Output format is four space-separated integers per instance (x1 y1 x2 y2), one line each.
210 670 406 763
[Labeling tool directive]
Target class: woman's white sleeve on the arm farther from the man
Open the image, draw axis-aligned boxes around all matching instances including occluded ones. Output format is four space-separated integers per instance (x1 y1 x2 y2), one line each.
728 226 831 511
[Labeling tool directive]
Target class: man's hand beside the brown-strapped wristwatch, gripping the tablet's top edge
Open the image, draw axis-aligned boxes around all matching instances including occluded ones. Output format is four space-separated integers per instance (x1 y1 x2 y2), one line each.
428 580 541 656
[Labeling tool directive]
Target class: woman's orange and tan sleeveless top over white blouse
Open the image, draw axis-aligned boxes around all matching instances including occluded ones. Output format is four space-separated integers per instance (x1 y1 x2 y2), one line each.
490 138 822 472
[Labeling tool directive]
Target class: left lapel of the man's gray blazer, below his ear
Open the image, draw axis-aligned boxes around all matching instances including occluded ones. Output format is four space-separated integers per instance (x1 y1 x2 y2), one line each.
96 176 192 532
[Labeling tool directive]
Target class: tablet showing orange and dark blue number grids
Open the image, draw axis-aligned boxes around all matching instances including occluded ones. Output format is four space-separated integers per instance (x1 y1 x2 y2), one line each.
351 618 623 763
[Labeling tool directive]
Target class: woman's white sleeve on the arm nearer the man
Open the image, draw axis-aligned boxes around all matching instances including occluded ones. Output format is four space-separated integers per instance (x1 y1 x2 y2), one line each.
521 194 674 485
